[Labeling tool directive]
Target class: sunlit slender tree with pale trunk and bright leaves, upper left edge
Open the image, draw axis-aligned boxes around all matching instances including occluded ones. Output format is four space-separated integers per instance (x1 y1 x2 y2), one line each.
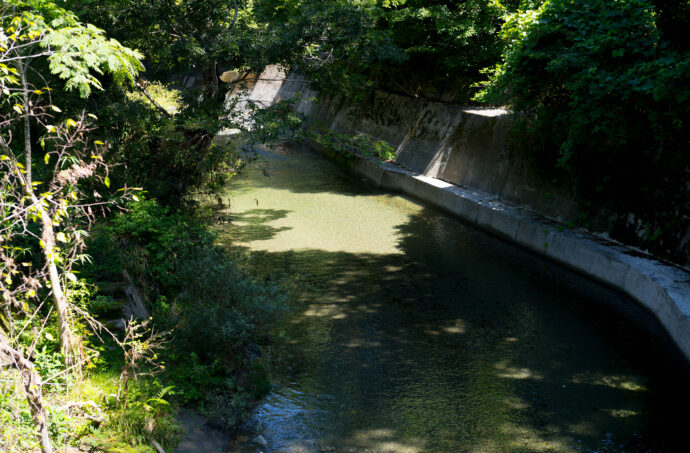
0 0 141 365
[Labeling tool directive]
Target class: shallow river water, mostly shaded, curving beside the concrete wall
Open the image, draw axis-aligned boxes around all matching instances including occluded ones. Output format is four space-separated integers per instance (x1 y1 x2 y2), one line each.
218 146 690 453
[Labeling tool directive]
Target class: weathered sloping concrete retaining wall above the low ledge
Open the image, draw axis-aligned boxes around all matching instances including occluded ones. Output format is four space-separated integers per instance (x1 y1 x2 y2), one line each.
278 86 579 222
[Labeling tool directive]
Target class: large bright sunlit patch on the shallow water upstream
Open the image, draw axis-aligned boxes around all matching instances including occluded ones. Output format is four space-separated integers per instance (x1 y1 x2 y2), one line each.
218 147 422 255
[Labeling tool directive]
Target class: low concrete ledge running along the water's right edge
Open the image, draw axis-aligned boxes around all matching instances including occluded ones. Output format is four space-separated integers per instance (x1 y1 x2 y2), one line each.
336 152 690 362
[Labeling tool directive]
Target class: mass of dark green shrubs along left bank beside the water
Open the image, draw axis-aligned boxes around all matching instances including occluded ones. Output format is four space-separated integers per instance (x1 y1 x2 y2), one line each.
84 196 286 427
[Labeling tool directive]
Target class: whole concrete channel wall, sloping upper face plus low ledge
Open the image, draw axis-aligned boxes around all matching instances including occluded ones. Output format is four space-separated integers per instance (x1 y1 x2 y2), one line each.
235 68 690 362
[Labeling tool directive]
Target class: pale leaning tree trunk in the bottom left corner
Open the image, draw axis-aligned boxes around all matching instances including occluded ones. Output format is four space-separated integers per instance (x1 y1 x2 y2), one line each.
0 333 54 453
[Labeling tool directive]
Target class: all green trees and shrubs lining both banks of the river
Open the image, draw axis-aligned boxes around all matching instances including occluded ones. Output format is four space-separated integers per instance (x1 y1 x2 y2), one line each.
0 0 690 452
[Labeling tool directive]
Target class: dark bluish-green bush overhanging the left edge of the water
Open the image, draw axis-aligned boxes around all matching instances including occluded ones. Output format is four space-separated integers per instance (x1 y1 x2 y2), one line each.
169 249 286 428
